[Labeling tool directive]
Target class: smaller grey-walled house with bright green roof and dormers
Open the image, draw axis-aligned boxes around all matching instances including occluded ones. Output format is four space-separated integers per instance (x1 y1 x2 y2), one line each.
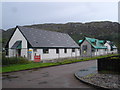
78 37 115 57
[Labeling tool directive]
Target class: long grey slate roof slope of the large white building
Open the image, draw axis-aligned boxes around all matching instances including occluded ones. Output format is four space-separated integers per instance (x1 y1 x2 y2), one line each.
18 26 79 48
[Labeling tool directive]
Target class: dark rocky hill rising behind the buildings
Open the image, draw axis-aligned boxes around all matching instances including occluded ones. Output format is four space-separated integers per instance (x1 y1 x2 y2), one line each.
3 21 119 46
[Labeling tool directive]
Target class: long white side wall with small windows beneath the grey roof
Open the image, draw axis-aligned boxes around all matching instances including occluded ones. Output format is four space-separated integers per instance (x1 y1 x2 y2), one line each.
32 49 80 60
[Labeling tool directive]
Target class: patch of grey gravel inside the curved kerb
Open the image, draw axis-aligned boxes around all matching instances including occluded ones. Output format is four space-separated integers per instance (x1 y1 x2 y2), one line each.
82 73 120 88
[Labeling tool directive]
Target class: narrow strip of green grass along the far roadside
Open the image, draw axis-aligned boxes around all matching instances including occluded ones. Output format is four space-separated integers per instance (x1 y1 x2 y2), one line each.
0 54 116 73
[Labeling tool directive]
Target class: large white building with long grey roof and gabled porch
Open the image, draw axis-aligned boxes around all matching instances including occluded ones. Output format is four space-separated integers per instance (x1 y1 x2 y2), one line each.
6 26 80 61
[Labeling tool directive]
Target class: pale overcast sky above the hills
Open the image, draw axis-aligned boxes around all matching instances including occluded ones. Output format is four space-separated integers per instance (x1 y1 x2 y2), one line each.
0 2 118 30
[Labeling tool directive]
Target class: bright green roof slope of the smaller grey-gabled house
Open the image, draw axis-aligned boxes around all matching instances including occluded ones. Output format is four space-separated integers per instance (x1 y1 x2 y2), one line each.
79 37 107 49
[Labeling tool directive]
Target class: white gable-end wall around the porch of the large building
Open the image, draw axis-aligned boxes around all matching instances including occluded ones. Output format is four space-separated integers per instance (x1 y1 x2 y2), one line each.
9 28 27 57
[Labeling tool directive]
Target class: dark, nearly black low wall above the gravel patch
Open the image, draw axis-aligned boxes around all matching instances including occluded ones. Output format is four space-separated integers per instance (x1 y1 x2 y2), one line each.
97 55 120 73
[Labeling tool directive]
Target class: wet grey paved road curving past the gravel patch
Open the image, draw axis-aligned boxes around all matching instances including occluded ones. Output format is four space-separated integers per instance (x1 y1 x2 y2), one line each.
3 60 96 90
